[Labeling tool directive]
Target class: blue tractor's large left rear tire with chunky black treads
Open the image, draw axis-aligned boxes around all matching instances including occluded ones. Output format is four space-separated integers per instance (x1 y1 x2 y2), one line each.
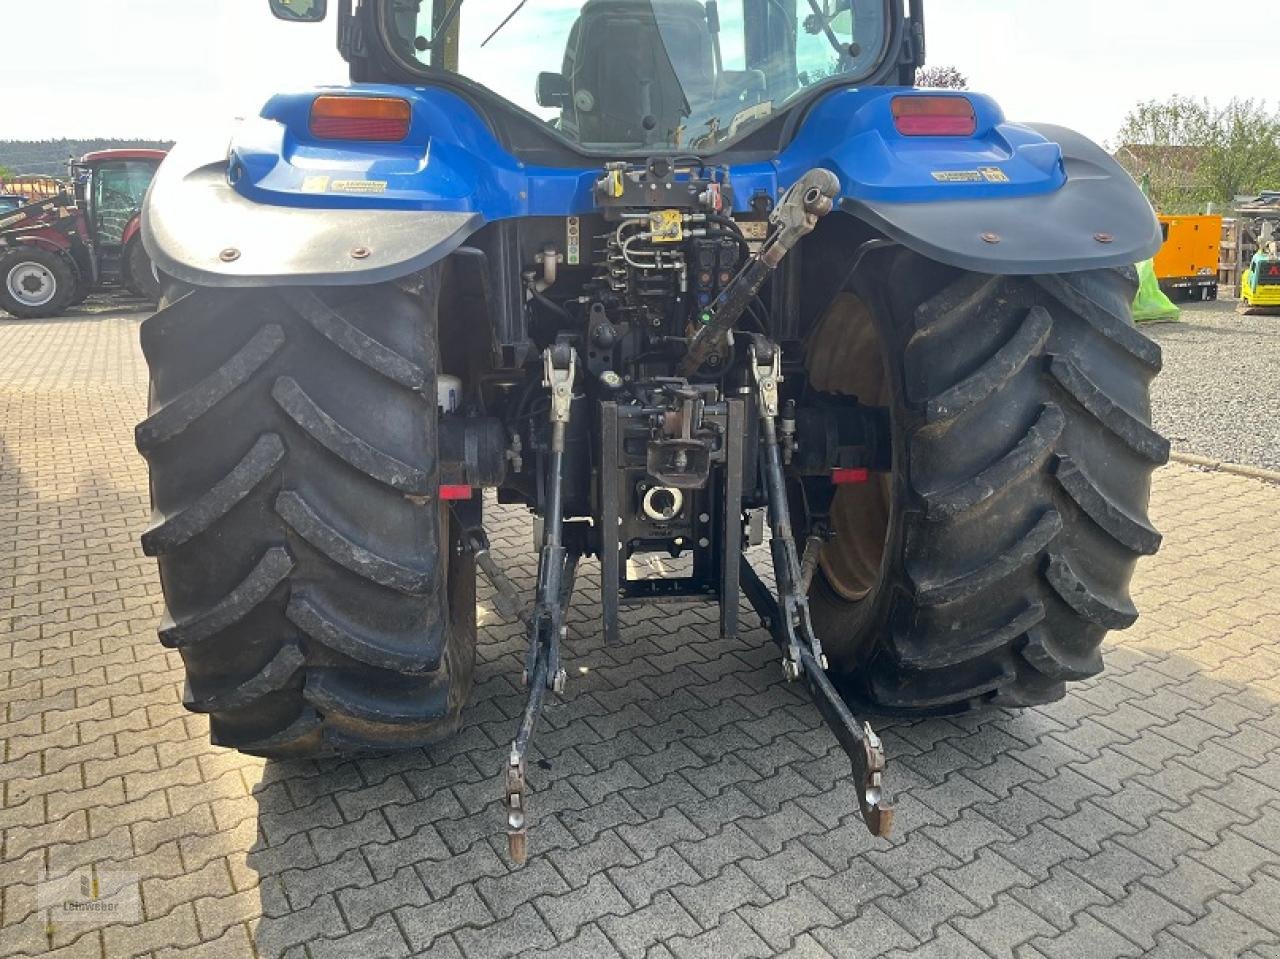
136 277 476 757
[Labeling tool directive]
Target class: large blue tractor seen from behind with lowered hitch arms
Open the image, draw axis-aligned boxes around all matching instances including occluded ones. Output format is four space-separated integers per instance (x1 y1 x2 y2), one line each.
137 0 1169 860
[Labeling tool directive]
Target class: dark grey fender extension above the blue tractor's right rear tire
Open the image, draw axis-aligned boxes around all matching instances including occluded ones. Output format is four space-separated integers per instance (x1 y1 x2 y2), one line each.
841 123 1161 275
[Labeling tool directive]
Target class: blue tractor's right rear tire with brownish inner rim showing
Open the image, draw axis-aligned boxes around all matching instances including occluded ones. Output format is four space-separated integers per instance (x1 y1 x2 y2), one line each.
809 251 1169 716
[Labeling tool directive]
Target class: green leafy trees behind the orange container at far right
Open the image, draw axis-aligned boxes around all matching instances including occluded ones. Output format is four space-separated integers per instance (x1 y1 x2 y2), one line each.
1116 96 1280 213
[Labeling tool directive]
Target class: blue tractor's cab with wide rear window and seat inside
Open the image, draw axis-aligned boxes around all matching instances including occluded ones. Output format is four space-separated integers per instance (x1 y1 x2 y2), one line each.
303 0 923 155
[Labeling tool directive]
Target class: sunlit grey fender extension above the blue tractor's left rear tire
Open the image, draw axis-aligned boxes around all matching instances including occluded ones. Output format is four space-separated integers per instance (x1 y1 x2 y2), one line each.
142 132 483 287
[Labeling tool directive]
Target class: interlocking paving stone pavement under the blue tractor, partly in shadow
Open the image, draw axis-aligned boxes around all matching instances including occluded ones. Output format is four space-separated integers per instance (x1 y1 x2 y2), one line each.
0 314 1280 959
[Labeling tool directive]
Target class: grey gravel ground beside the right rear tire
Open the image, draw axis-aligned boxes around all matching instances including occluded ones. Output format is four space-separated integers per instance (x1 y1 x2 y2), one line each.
1143 301 1280 470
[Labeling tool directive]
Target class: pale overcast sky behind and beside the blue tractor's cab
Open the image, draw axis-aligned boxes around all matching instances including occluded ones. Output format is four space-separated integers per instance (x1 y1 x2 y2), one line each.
0 0 1259 163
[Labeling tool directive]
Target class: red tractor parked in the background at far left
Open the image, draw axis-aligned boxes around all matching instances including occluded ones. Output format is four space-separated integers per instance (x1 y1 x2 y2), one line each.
0 150 165 319
